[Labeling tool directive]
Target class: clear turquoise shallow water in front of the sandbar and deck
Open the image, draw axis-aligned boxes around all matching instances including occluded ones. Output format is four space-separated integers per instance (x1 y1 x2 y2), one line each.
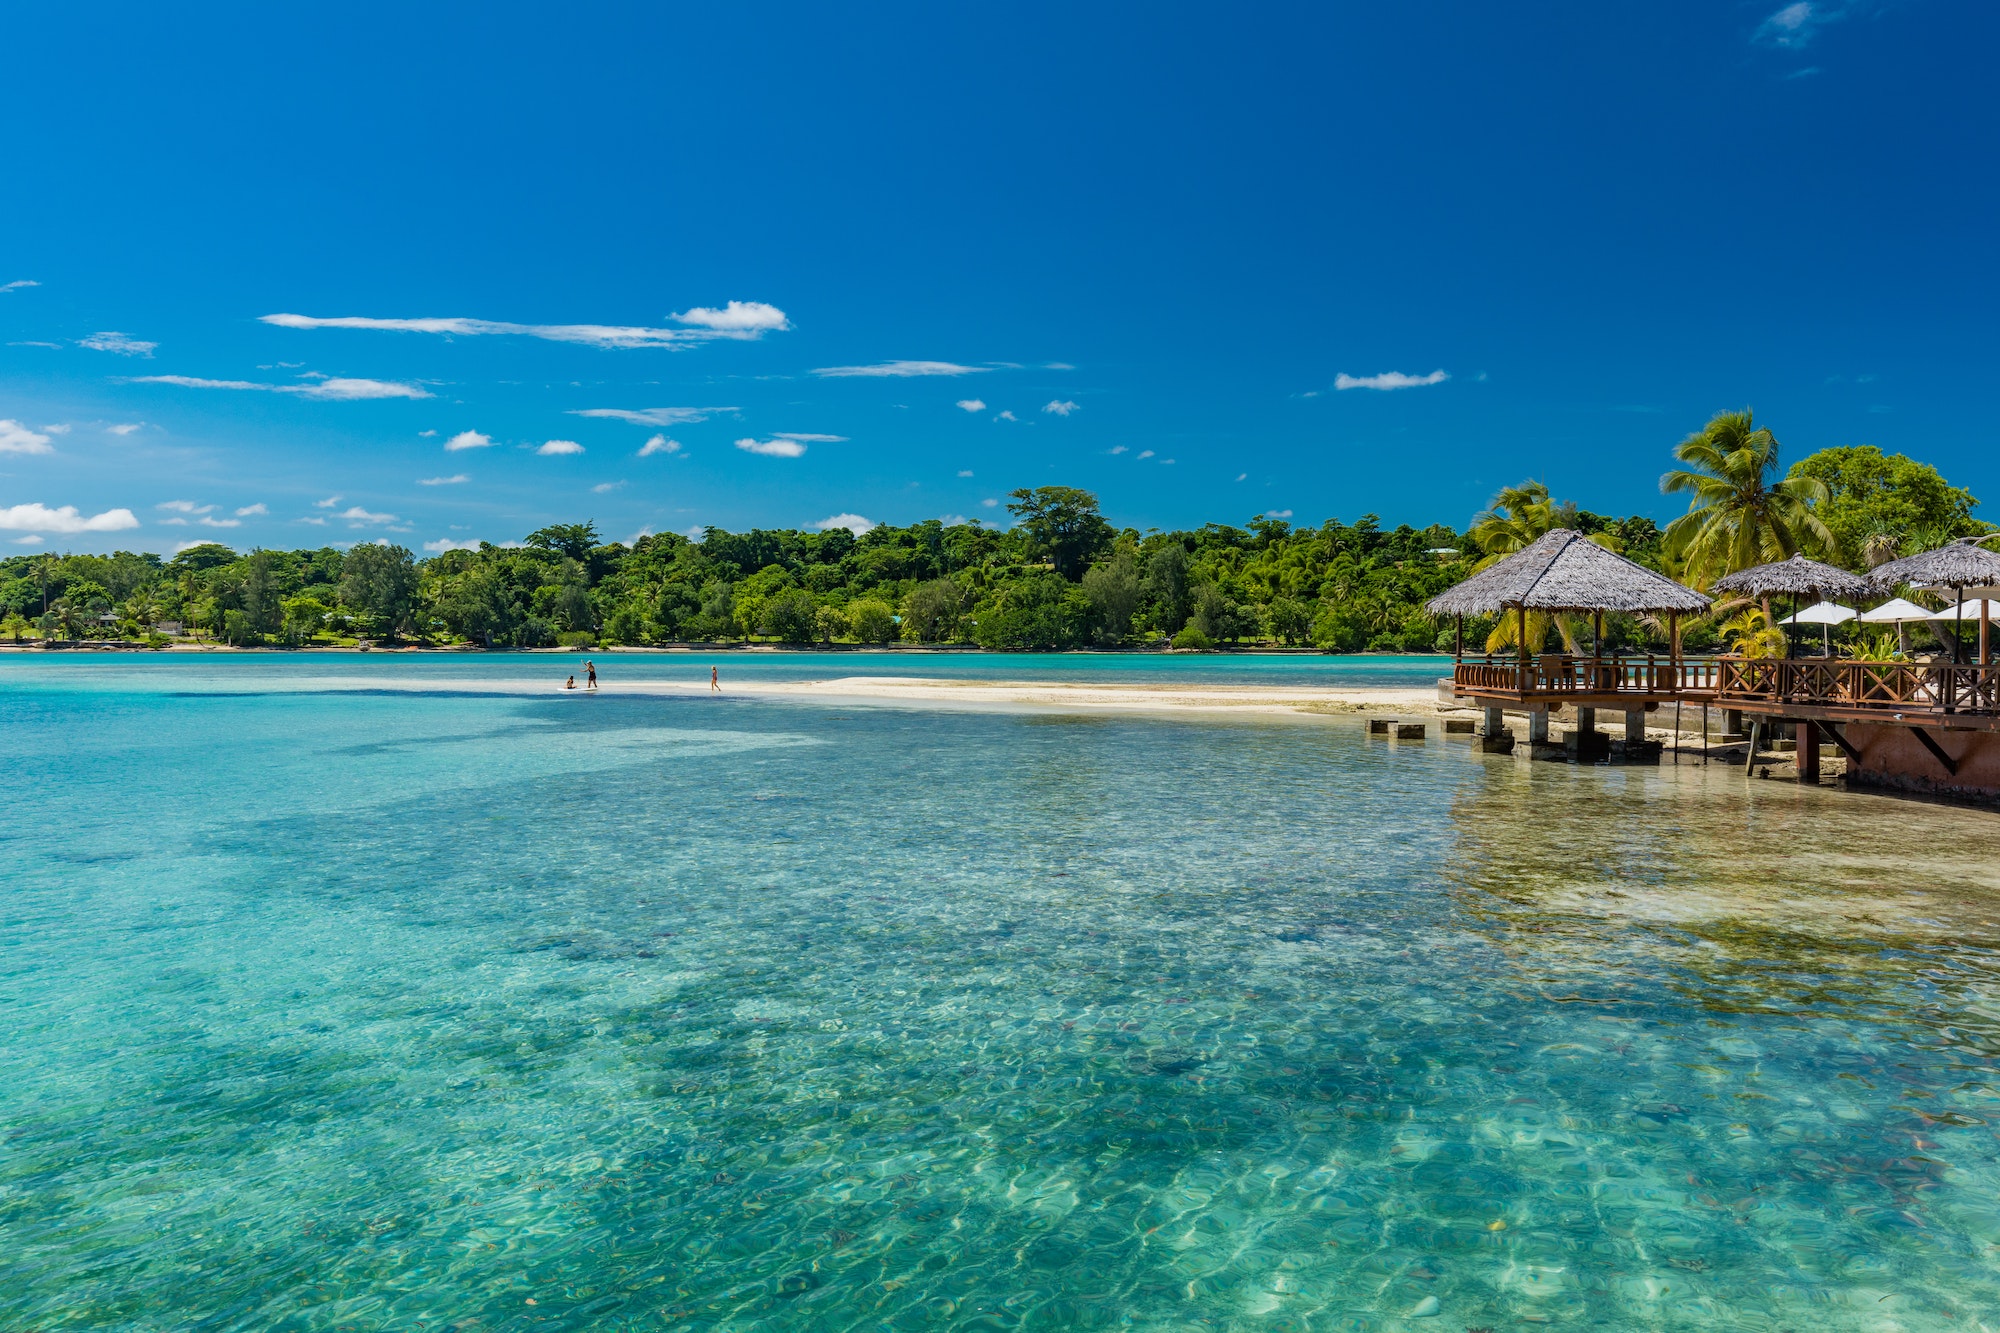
0 656 2000 1331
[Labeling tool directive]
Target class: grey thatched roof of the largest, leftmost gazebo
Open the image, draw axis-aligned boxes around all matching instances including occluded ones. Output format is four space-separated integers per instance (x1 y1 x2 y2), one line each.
1424 528 1708 616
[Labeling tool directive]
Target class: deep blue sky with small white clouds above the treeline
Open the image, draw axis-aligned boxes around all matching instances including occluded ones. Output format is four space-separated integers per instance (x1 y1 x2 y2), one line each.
0 0 2000 552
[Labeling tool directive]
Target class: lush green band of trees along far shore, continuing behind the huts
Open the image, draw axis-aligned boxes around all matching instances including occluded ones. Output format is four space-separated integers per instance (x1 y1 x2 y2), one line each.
0 414 1988 652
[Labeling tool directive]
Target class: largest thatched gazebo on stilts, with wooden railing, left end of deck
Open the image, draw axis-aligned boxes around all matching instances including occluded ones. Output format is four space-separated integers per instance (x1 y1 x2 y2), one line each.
1424 528 1708 743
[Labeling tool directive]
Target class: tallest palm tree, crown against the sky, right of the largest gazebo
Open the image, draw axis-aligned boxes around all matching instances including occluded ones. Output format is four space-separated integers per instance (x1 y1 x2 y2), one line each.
1660 408 1834 586
